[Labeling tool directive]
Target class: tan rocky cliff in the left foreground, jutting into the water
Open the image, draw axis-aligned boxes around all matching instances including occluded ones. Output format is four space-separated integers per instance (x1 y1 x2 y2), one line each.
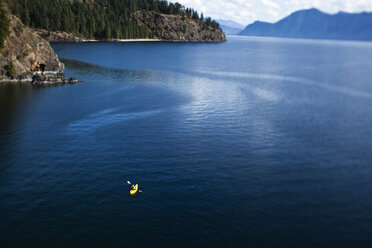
0 15 75 83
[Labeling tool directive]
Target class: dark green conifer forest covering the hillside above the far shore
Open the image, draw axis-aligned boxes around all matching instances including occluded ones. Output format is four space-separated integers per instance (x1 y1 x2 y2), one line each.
5 0 219 39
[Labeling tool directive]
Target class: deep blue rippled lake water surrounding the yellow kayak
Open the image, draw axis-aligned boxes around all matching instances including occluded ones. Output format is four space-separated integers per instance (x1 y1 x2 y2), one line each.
0 37 372 248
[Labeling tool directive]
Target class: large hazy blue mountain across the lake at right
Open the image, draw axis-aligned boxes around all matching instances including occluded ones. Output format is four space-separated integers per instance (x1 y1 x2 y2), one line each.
239 9 372 40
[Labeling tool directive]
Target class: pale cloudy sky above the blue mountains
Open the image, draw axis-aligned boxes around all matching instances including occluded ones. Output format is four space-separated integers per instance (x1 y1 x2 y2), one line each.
172 0 372 25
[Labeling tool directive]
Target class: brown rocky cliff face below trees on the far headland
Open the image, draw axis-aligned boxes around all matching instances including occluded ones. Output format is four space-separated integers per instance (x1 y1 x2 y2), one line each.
133 11 226 42
